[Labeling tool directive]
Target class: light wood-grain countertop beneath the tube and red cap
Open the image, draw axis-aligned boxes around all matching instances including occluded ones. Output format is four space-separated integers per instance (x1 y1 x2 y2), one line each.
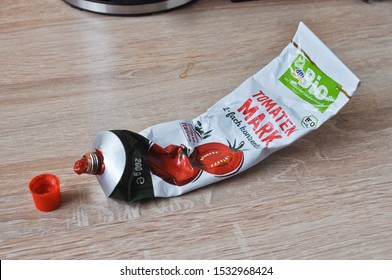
0 0 392 259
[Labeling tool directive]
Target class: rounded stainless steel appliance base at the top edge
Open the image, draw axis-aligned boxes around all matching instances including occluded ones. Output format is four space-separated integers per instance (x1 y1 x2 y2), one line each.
63 0 193 15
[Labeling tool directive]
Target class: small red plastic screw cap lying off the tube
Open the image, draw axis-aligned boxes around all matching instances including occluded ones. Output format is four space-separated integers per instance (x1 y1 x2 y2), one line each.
29 174 61 212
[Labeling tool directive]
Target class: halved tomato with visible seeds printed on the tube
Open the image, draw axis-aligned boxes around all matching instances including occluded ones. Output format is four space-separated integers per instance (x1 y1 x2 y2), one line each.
190 141 245 176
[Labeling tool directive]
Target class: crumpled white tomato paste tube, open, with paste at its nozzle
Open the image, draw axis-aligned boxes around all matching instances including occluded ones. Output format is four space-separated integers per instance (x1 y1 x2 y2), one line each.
74 23 360 201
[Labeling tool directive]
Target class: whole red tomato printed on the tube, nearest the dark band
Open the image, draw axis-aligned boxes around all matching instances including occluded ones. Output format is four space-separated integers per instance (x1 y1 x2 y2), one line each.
148 144 202 186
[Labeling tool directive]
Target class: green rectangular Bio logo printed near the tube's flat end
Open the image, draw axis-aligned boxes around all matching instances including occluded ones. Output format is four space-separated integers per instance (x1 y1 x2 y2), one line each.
279 54 341 113
